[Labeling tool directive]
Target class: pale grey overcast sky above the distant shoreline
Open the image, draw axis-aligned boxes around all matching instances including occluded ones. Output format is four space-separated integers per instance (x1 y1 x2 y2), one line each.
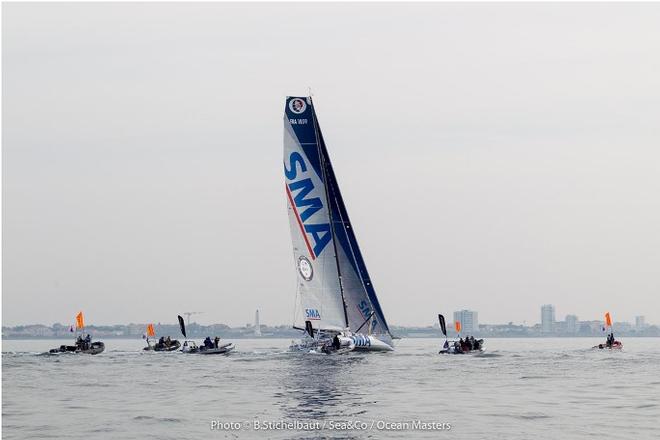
2 3 660 325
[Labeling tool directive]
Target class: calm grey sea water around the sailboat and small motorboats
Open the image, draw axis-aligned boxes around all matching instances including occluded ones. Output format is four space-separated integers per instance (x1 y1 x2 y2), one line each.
2 338 660 440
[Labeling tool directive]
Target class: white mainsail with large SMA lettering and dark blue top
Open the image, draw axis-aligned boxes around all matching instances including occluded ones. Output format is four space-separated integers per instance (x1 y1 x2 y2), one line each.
284 98 347 330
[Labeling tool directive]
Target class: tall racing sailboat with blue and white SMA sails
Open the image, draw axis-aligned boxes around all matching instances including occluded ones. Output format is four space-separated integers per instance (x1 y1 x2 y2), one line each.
284 96 394 353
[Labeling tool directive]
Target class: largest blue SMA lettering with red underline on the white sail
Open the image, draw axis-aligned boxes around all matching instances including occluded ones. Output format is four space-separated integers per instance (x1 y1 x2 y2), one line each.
284 151 332 260
